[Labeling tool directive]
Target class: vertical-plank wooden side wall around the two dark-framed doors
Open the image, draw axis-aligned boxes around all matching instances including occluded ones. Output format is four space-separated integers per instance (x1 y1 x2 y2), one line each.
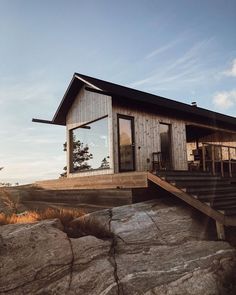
112 104 188 173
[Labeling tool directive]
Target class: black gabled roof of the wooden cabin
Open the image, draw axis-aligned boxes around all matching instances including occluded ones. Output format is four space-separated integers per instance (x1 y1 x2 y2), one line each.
33 73 236 131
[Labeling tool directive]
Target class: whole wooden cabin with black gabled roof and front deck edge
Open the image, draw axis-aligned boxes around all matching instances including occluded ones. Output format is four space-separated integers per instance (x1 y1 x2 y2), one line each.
33 73 236 239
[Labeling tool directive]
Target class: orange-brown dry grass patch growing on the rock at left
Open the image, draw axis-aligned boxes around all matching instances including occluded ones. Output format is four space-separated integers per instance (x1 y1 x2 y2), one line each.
0 208 113 239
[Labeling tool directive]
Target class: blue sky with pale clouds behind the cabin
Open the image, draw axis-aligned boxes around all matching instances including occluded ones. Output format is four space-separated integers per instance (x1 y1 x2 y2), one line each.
0 0 236 184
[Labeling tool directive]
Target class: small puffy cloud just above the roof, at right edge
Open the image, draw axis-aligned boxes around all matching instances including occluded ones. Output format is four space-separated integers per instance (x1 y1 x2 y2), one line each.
213 90 236 110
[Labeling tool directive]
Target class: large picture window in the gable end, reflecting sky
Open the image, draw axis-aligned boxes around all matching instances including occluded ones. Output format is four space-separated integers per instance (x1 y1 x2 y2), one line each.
71 117 110 172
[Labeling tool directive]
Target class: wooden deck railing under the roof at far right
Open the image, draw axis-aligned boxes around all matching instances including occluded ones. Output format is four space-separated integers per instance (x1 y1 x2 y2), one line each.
202 142 236 177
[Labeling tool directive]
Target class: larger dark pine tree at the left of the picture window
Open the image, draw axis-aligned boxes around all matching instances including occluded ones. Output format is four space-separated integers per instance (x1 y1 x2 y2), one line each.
61 136 93 177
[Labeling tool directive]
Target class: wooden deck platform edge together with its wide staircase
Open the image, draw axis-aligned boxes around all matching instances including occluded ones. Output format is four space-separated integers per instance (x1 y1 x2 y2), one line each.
35 171 236 239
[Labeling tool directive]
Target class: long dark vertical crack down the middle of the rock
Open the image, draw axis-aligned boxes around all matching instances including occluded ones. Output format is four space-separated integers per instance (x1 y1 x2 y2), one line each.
108 209 124 295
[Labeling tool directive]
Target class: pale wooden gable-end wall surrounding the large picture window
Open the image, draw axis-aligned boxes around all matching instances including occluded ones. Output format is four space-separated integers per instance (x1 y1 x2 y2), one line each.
66 87 114 177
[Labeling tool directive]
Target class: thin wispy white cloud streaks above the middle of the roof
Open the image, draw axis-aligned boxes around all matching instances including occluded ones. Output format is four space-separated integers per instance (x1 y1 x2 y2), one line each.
130 38 216 91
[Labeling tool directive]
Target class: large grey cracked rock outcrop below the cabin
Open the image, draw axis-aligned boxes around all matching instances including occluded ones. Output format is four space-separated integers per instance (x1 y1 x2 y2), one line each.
0 200 236 295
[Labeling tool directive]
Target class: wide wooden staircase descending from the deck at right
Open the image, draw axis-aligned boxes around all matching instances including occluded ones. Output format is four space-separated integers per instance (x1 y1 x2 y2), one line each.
147 170 236 239
